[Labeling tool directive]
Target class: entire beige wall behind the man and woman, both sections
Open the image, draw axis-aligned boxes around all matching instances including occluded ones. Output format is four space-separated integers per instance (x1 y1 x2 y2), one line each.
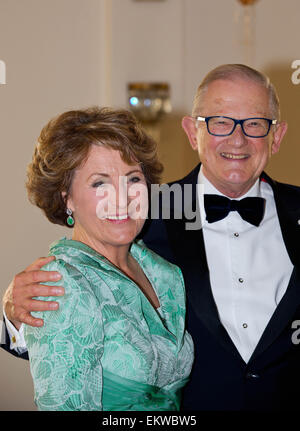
0 0 300 410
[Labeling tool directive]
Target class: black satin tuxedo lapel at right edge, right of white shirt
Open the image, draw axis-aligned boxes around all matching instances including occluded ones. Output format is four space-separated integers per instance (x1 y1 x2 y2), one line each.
250 174 300 361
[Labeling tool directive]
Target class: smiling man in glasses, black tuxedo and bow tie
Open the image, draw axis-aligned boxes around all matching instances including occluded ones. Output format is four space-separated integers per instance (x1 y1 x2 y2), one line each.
4 65 300 410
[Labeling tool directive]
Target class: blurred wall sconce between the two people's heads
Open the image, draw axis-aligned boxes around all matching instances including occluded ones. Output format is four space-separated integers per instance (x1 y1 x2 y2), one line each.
127 82 172 123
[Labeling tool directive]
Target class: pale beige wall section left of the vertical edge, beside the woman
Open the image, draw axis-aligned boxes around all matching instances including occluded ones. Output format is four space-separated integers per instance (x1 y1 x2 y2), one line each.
0 0 102 410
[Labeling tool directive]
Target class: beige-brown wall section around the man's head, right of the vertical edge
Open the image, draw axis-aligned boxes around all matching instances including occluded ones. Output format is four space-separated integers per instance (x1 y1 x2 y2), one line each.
111 0 300 185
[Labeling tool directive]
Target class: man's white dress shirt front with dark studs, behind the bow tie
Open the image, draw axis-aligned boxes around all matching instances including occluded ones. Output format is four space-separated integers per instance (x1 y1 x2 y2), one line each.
198 169 293 362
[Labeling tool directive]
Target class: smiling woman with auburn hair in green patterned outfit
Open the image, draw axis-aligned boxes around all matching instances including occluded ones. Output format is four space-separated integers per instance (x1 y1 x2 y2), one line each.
25 108 193 410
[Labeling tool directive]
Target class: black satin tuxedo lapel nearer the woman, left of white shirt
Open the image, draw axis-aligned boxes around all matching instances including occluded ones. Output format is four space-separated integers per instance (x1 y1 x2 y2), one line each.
165 167 242 360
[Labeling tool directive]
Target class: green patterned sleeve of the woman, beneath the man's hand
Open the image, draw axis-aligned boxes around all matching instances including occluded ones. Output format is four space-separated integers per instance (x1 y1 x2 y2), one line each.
24 260 103 411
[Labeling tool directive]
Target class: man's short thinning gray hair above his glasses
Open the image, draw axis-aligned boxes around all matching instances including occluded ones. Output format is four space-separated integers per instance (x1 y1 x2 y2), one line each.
192 64 280 121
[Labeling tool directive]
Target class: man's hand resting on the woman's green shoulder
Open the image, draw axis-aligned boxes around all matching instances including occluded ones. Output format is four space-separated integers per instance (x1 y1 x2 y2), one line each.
3 256 64 329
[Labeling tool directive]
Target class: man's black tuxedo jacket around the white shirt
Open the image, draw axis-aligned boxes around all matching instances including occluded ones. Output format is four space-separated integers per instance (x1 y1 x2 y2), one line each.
142 165 300 410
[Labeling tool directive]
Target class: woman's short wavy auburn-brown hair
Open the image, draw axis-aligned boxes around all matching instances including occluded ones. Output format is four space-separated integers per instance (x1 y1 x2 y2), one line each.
26 107 163 227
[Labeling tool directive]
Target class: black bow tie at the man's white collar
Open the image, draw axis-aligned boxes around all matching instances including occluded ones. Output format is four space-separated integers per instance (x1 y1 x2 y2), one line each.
204 195 266 226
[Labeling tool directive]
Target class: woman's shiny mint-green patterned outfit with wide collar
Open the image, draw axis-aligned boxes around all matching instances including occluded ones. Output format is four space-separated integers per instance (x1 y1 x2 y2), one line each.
25 238 193 411
